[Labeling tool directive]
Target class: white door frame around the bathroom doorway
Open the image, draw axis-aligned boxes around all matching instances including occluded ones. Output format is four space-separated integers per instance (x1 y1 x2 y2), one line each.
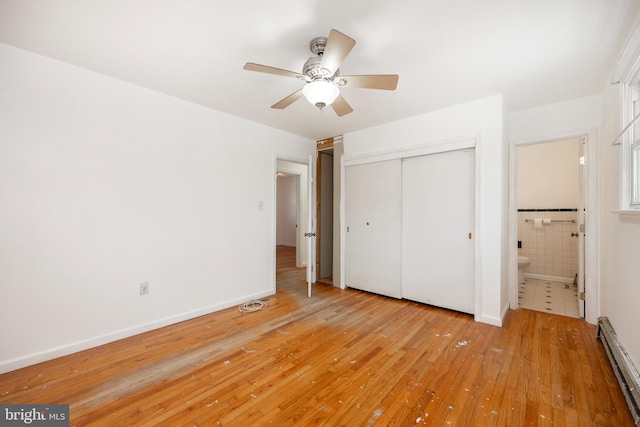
508 129 600 324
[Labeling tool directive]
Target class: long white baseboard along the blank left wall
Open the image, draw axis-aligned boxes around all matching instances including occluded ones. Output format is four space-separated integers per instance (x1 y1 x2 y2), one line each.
0 290 273 374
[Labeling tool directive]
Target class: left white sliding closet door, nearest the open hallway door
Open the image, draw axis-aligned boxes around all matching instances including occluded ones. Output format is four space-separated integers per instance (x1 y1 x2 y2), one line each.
345 159 402 298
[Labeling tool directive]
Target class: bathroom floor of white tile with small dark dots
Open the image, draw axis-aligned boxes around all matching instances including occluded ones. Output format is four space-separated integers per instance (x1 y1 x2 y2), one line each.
518 279 580 317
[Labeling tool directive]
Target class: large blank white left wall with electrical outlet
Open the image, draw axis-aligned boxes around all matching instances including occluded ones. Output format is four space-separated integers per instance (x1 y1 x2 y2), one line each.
0 41 315 372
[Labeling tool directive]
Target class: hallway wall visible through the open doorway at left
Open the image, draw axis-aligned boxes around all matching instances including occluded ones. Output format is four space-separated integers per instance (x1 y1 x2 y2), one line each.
276 175 299 247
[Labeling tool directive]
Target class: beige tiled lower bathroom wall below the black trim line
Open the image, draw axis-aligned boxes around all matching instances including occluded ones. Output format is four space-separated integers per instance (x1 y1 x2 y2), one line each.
518 209 579 280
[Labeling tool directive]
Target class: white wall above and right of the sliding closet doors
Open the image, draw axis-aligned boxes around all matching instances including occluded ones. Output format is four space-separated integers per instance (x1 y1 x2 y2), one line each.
344 96 508 326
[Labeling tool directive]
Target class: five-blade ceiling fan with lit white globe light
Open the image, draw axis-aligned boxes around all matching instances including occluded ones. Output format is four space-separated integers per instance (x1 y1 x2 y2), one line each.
243 30 398 117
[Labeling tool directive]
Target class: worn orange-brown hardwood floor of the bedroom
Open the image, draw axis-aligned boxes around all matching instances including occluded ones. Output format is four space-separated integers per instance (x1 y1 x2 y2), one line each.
0 247 633 427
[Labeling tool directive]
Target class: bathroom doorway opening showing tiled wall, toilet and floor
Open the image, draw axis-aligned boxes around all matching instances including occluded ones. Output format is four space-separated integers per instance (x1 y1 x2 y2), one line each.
515 137 586 317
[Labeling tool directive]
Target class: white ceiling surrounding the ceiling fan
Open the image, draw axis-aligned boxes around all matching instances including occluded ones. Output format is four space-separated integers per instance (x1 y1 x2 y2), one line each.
0 0 640 139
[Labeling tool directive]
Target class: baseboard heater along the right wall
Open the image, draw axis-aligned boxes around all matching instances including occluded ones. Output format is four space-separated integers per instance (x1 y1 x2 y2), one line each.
598 317 640 426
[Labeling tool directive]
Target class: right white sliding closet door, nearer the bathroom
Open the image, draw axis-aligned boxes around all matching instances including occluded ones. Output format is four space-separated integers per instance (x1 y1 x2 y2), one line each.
402 149 475 313
